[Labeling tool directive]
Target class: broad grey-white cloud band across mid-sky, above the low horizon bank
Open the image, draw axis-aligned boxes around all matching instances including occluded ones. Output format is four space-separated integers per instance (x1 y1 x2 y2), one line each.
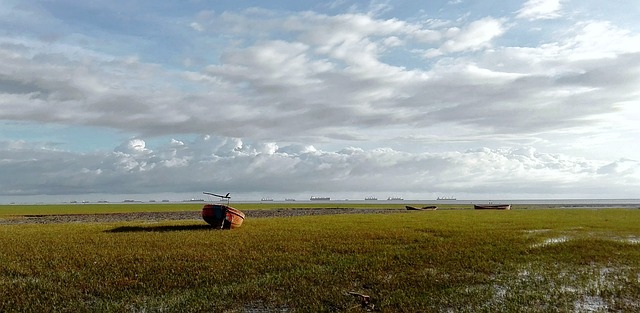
0 10 640 146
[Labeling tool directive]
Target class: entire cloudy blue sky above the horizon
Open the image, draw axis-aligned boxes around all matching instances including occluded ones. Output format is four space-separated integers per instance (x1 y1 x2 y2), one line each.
0 0 640 203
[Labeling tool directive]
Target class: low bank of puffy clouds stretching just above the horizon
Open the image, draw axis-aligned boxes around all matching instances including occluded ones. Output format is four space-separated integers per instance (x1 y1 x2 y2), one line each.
0 136 640 198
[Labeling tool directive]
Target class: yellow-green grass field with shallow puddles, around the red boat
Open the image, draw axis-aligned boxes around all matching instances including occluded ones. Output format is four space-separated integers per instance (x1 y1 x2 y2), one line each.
0 205 640 312
